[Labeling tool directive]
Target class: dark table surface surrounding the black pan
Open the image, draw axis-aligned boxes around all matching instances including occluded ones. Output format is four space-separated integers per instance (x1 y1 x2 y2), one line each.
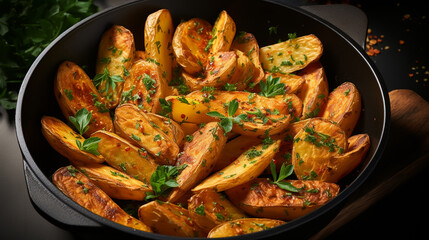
0 1 429 240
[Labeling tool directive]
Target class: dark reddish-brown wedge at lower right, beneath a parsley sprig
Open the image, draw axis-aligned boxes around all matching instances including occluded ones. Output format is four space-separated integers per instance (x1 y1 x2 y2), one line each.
226 178 340 220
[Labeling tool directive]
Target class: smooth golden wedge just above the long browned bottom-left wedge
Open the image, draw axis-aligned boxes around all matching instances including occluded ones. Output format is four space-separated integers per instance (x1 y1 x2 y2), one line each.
77 164 152 201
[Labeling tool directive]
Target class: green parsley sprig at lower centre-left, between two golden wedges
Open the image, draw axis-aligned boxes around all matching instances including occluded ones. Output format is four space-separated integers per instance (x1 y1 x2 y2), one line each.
145 164 187 201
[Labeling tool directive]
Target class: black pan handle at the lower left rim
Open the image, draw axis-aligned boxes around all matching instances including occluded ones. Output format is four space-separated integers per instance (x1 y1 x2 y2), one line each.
22 159 102 227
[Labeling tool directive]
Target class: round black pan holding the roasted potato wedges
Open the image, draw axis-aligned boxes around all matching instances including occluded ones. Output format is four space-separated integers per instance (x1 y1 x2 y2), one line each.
16 0 390 239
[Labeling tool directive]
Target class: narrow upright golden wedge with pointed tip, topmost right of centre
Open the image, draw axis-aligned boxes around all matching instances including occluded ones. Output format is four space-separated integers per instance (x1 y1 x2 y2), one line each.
208 10 236 56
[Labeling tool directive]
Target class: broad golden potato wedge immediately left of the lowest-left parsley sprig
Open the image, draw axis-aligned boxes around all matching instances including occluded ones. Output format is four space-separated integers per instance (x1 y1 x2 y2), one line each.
92 130 158 185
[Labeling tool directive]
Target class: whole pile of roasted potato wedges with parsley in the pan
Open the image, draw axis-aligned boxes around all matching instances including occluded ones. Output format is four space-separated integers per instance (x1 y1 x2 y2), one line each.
41 9 370 238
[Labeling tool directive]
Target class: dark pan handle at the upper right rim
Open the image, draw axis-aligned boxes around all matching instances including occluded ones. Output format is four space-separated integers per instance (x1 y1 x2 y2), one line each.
300 4 368 49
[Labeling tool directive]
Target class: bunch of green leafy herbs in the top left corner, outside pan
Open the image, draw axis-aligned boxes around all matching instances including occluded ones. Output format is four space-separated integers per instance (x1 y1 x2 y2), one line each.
0 0 98 109
